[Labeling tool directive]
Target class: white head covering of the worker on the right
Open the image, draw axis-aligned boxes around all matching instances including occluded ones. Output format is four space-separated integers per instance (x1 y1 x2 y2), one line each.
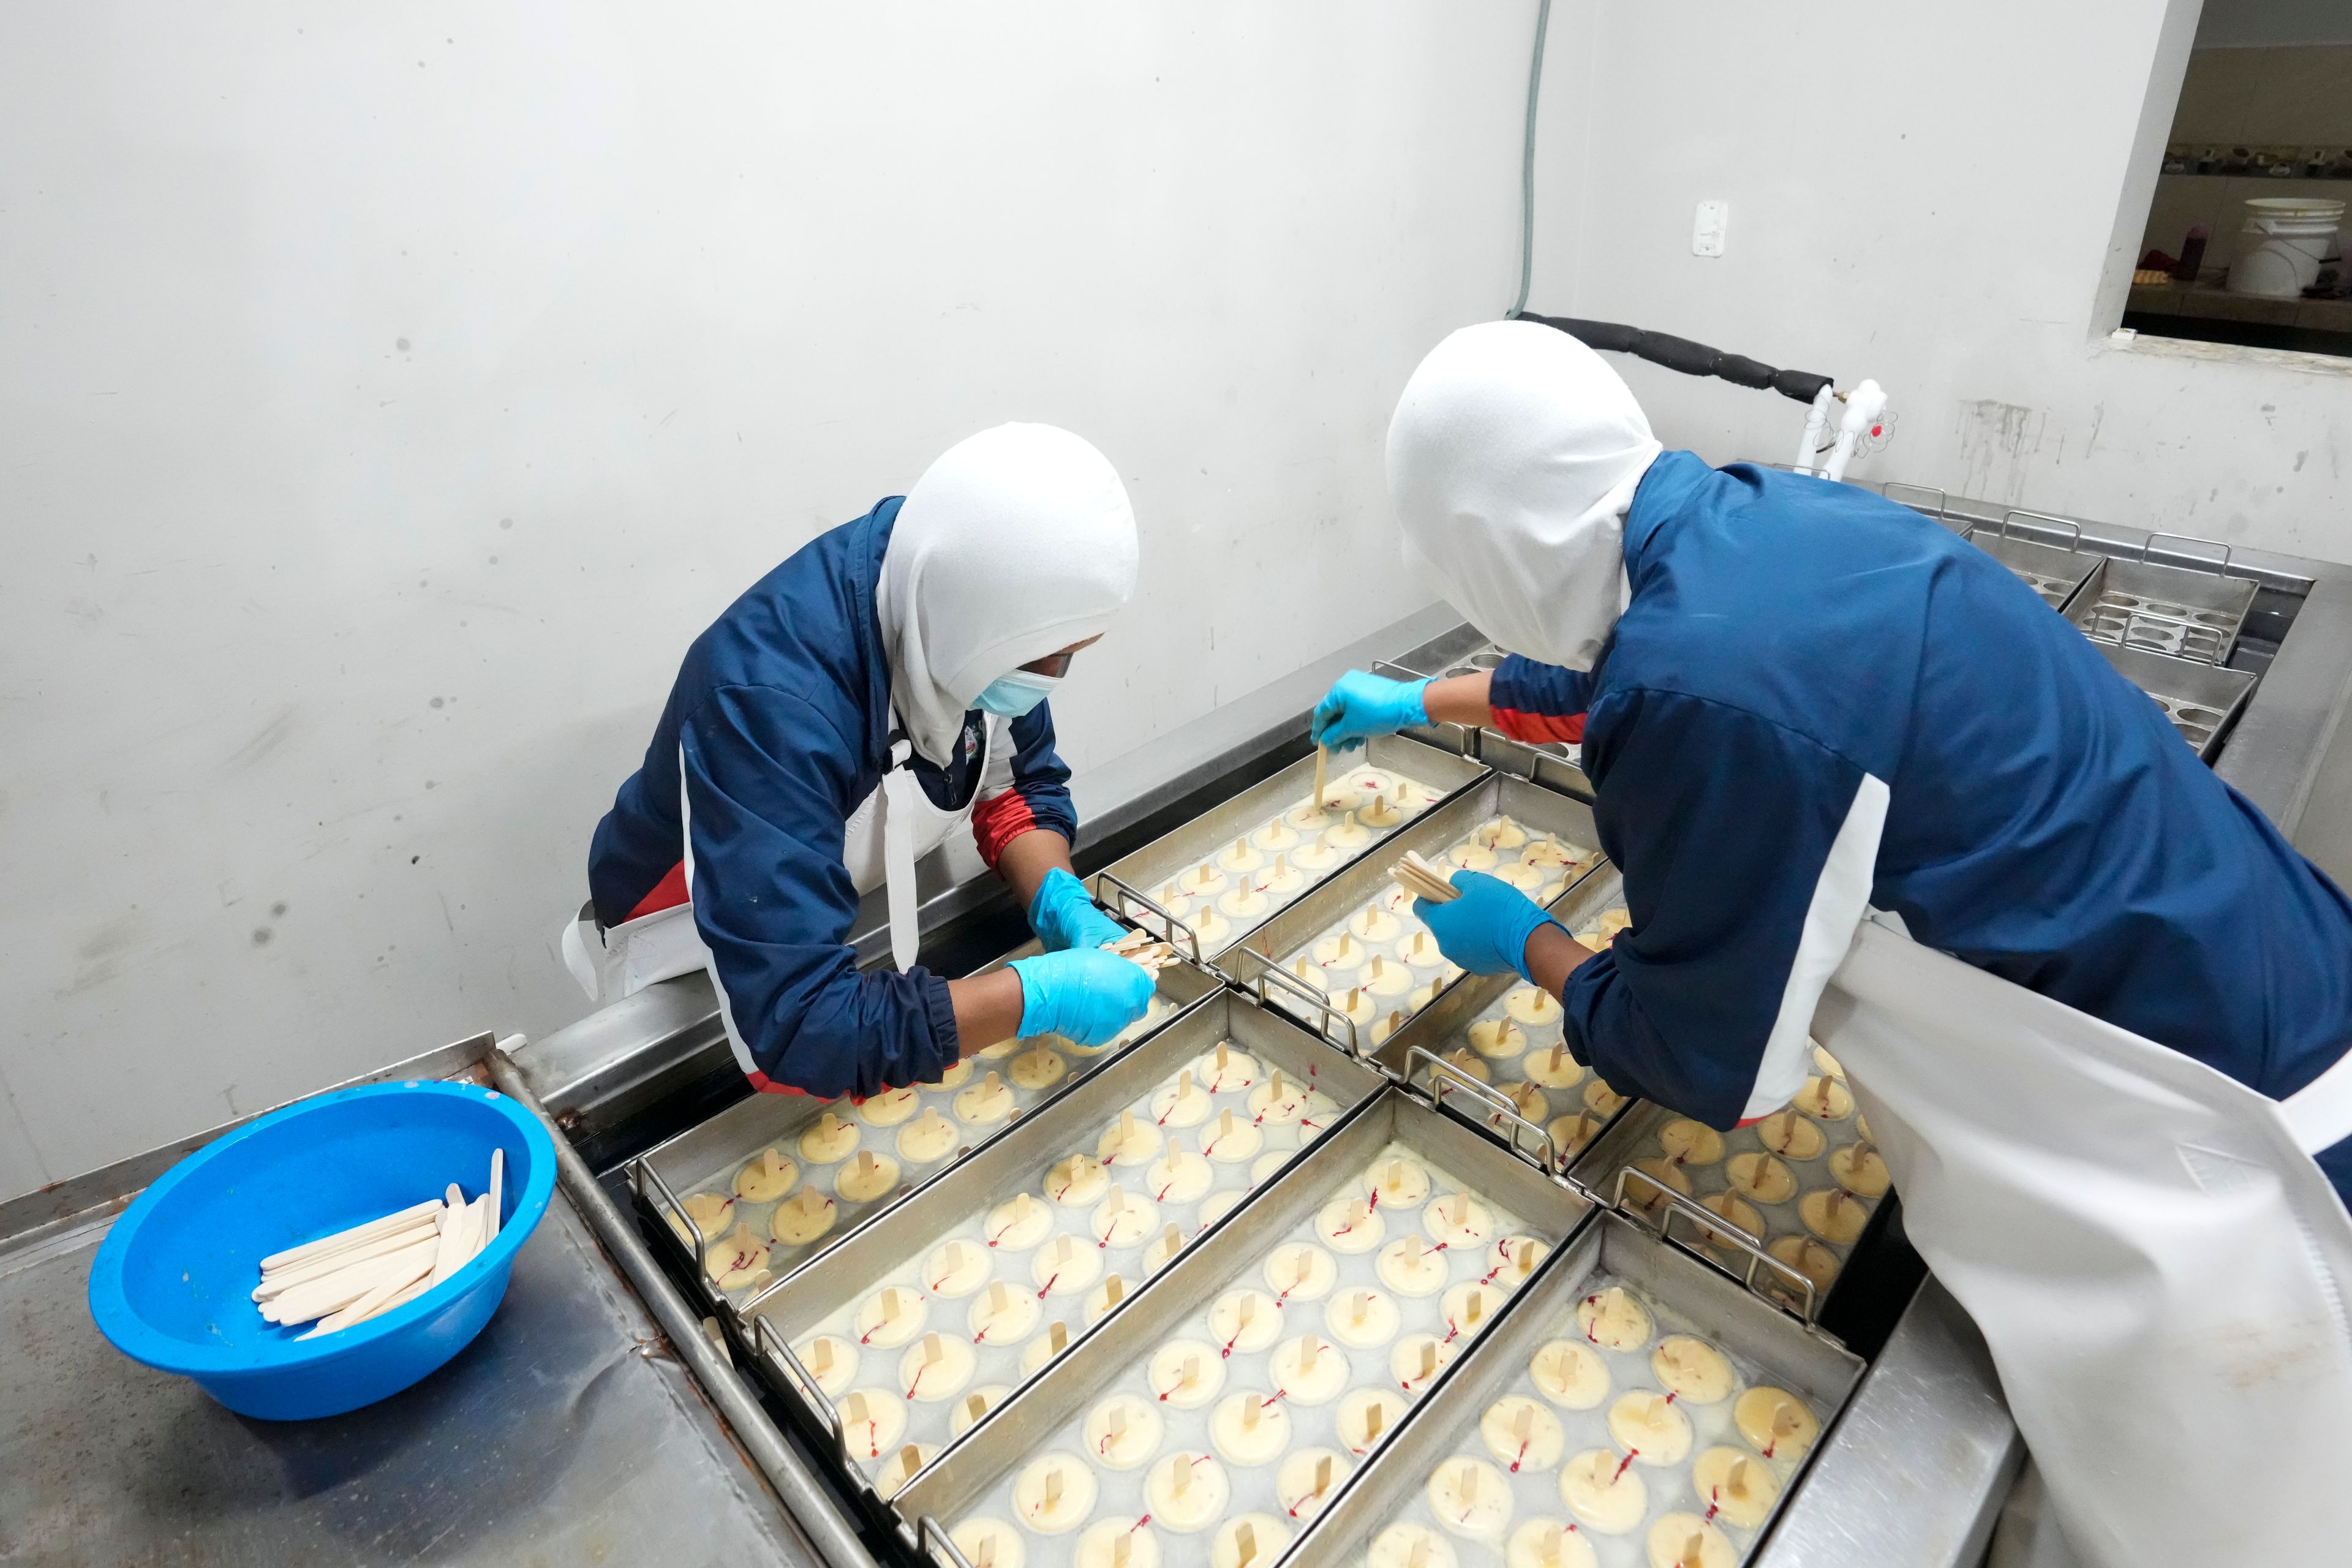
1388 322 1660 670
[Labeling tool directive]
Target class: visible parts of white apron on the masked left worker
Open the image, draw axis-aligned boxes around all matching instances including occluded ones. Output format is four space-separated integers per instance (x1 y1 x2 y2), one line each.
562 715 997 1006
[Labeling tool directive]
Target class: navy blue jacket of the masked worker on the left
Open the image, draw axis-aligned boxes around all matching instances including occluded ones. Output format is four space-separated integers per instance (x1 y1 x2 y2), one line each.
588 510 1077 1098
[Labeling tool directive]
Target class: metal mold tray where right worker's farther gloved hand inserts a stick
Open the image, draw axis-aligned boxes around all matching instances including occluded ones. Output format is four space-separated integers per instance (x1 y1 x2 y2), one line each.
1089 736 1484 964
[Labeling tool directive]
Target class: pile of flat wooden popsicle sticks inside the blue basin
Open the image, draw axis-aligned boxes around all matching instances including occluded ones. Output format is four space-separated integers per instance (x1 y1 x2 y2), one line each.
254 1150 506 1340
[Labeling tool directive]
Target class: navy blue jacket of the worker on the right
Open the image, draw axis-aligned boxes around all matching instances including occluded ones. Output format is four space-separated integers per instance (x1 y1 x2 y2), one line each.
1493 451 2352 1189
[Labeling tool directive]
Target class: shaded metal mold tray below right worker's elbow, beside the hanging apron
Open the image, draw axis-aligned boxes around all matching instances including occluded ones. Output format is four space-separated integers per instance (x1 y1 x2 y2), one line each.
1571 1046 1887 1310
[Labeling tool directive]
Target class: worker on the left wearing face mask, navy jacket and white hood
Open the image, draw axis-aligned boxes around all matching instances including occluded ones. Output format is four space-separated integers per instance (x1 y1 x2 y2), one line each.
565 426 1153 1096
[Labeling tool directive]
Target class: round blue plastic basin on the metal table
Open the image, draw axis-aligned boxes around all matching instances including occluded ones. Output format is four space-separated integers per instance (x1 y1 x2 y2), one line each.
89 1082 555 1420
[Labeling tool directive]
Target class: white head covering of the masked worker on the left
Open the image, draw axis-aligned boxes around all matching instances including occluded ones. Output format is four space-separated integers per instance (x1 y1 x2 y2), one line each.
877 426 1136 762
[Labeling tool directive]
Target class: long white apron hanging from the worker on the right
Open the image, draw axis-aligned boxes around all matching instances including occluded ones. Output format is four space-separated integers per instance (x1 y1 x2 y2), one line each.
1814 922 2352 1568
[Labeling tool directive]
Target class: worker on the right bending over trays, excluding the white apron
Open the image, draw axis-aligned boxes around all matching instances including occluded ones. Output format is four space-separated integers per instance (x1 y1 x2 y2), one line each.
1315 322 2352 1194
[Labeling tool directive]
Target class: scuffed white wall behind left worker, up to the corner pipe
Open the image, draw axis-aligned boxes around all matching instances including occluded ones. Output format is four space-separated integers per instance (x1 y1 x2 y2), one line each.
0 0 1534 1194
